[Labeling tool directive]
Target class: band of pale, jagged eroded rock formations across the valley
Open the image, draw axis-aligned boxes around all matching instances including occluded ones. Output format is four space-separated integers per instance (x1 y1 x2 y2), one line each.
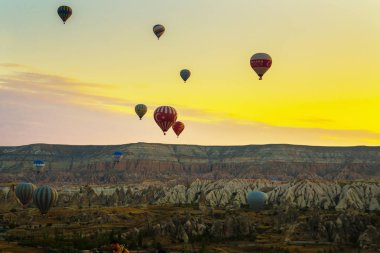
0 179 380 211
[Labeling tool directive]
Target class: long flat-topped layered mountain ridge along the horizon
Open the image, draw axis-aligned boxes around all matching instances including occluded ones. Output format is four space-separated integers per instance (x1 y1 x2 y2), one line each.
0 143 380 184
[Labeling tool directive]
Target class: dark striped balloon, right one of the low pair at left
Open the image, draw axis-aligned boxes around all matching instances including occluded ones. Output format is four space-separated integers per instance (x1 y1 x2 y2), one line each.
33 185 58 214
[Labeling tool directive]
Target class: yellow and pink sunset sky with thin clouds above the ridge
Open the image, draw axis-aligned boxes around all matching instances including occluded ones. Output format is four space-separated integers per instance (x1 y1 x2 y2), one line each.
0 0 380 146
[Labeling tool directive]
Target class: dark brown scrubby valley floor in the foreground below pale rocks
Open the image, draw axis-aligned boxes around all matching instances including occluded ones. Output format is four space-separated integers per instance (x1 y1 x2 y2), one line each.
0 206 380 253
